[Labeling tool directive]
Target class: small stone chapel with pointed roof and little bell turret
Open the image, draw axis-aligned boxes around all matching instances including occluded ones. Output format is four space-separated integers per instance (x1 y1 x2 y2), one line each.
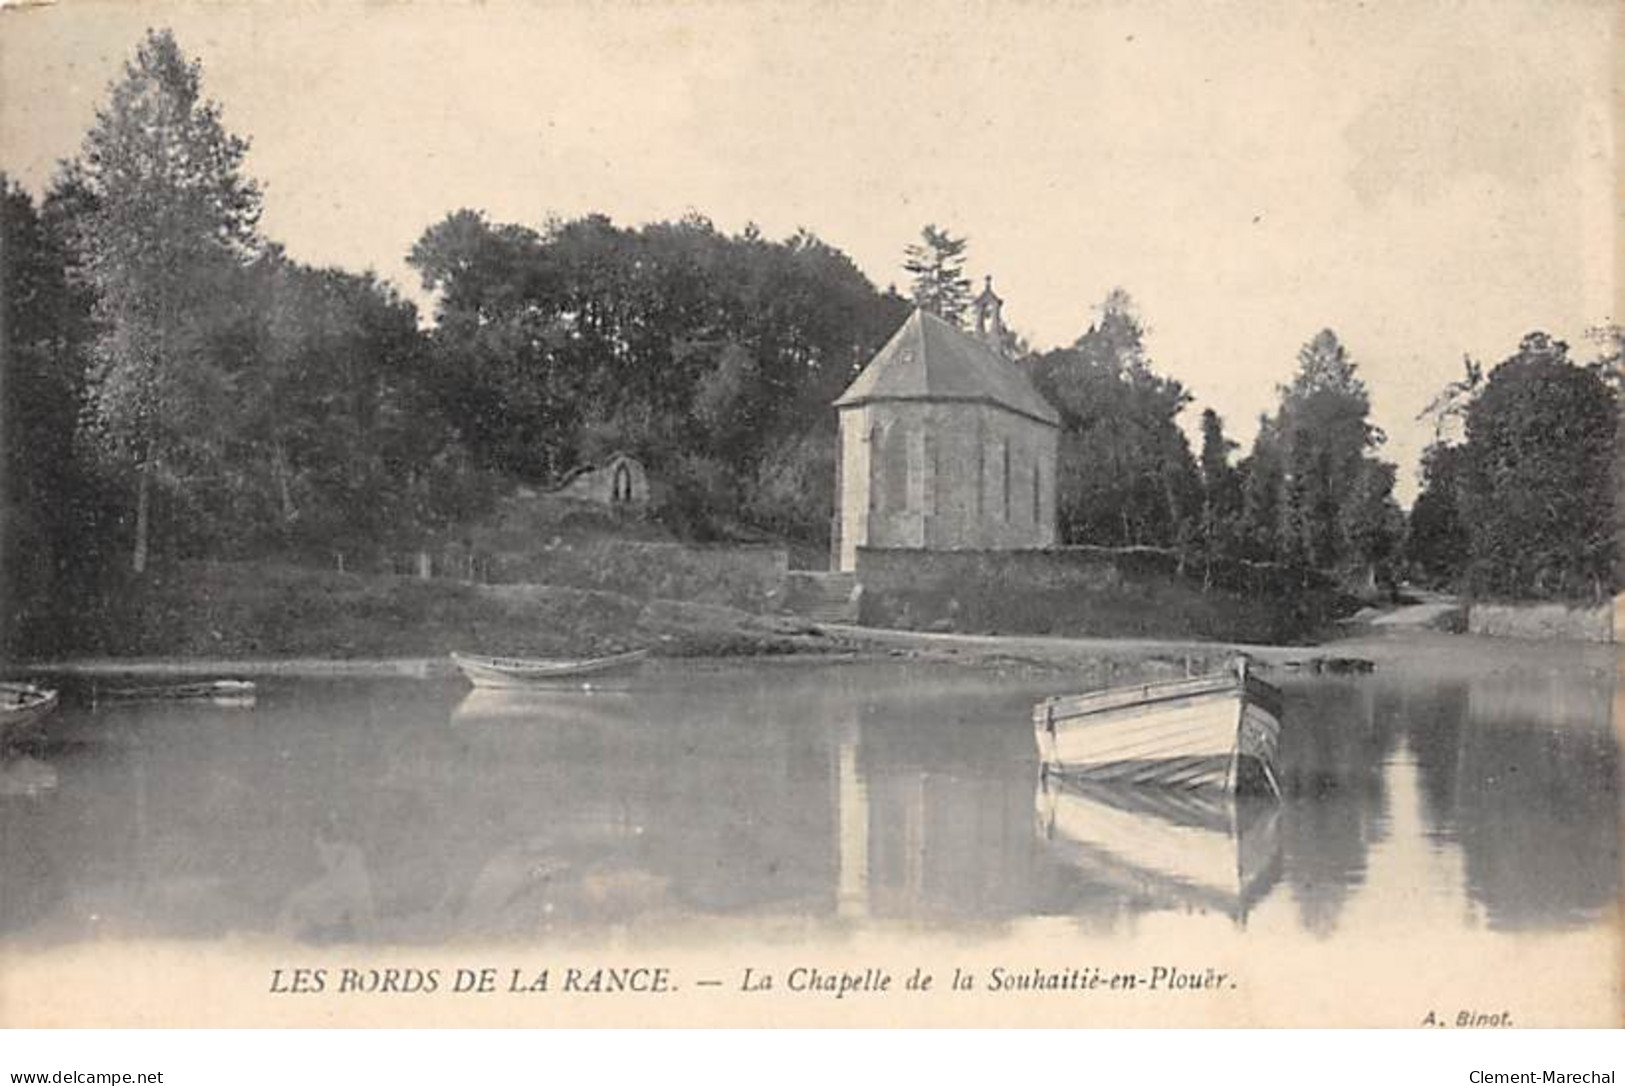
832 280 1060 571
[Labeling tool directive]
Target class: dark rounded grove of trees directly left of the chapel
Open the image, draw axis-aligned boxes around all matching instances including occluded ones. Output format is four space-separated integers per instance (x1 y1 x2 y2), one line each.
411 210 907 536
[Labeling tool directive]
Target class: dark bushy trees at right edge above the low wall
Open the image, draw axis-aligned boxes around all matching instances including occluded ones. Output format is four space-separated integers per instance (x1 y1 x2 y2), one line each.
1409 332 1619 600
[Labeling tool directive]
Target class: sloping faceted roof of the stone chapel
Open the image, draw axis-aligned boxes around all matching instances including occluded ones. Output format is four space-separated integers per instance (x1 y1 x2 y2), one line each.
835 309 1061 426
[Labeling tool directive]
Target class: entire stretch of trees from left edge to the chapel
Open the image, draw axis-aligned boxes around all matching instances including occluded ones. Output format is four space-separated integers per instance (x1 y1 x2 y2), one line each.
0 23 907 632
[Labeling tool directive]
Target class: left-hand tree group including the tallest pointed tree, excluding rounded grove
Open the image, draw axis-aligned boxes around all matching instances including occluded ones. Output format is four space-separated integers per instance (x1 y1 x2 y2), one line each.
0 31 483 650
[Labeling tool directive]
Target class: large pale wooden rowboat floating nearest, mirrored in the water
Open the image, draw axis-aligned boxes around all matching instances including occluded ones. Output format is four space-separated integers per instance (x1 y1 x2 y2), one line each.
1034 657 1282 798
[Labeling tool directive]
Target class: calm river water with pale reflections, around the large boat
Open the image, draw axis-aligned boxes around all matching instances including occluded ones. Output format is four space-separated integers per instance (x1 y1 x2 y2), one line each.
0 665 1620 943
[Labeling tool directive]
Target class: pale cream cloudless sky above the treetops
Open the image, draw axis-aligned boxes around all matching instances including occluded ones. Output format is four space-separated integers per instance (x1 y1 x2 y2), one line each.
0 0 1625 501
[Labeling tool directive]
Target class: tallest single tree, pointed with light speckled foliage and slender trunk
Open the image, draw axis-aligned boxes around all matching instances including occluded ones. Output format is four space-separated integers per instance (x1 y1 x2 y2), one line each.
60 29 260 571
